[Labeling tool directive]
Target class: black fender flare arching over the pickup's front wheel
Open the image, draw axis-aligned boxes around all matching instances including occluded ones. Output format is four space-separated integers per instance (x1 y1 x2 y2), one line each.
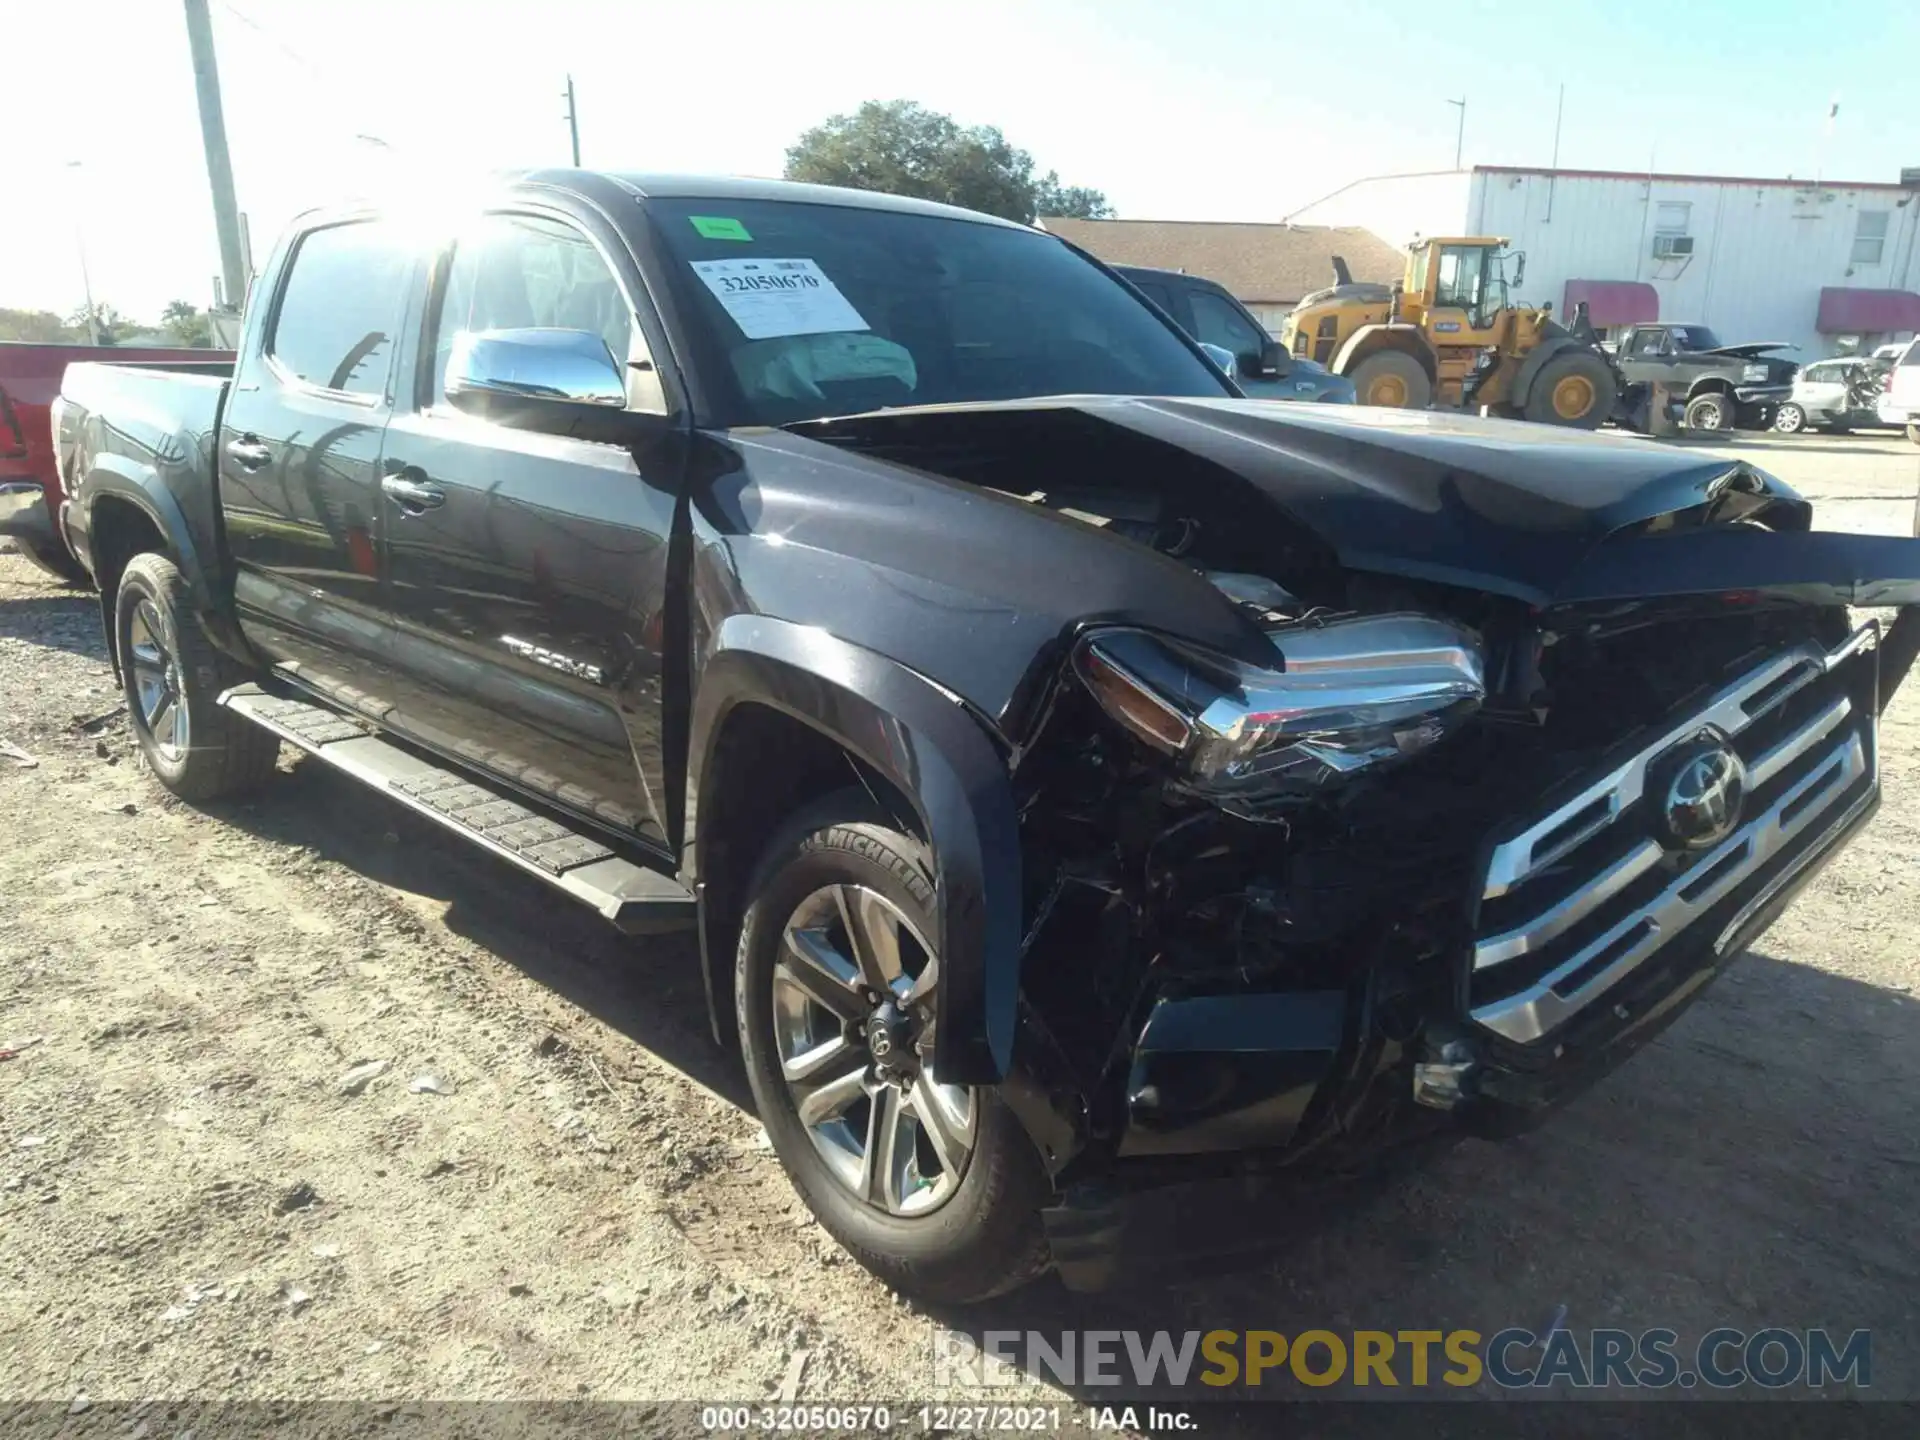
687 614 1021 1085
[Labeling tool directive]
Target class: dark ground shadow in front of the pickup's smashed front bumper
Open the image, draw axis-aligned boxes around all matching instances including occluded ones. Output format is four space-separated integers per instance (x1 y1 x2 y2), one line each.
943 950 1920 1432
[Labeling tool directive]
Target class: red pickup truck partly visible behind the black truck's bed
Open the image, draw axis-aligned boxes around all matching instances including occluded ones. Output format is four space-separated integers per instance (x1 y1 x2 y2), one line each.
0 344 234 584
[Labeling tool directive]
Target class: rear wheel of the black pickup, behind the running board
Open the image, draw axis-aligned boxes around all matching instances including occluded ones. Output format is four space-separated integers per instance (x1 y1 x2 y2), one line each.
113 555 280 801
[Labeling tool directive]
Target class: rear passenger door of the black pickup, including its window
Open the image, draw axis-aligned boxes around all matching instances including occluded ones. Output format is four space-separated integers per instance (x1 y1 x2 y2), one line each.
215 219 419 703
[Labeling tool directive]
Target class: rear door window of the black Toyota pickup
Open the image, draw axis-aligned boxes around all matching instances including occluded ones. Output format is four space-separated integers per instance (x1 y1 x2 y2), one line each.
267 221 411 396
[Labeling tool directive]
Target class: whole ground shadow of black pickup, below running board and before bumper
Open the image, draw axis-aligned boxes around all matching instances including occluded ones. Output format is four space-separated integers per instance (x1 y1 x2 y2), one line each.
213 744 1920 1413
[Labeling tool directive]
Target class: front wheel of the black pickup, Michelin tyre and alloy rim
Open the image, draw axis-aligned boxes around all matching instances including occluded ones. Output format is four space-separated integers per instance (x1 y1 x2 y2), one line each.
733 791 1050 1304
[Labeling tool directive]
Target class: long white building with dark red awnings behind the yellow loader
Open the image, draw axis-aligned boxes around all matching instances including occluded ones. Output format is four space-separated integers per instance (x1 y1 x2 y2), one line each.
1286 165 1920 359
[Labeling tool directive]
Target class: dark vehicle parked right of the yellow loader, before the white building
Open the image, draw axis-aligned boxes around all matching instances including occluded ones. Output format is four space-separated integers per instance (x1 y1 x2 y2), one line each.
1615 324 1795 430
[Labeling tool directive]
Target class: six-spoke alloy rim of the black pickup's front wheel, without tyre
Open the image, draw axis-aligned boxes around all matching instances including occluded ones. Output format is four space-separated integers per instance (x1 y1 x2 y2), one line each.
772 883 979 1215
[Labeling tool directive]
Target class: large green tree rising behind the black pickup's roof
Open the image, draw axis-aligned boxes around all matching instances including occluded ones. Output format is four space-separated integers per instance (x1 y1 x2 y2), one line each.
787 100 1114 223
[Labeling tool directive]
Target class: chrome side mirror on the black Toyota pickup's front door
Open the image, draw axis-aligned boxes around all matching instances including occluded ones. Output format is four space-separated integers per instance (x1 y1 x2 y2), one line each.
445 330 626 440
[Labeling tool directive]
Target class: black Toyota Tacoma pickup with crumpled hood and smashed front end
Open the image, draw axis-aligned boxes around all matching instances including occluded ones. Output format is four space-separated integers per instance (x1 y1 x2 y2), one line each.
58 171 1920 1300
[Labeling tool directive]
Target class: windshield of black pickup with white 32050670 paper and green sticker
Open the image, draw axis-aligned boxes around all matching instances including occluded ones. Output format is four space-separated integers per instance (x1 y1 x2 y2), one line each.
647 200 1231 424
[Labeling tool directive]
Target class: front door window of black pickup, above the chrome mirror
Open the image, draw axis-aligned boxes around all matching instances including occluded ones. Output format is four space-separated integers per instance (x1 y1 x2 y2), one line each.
428 215 634 403
